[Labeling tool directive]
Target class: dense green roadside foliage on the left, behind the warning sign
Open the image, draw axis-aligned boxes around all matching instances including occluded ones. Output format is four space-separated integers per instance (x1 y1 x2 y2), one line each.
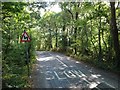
2 2 35 88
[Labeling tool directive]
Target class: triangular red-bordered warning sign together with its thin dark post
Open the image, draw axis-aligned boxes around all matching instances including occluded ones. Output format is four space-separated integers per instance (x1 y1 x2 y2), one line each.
20 30 31 76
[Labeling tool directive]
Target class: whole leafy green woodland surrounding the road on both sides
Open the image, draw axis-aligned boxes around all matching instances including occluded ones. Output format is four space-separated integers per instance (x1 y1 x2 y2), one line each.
0 2 120 88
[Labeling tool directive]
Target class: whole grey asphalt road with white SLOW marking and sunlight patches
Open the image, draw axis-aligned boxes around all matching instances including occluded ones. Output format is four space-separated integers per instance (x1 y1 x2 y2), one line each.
31 51 120 90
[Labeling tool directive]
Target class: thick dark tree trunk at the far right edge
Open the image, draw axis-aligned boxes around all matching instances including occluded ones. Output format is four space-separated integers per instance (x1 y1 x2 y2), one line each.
110 2 120 67
